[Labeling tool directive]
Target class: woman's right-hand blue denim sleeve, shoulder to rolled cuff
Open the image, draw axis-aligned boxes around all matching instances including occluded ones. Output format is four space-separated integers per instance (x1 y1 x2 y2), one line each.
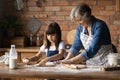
80 21 111 60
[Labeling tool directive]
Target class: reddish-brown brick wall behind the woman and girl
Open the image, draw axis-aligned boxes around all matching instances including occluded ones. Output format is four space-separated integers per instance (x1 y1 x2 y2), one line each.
2 0 120 52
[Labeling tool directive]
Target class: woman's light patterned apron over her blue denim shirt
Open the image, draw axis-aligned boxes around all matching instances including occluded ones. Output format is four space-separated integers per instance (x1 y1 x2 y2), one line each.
80 28 113 66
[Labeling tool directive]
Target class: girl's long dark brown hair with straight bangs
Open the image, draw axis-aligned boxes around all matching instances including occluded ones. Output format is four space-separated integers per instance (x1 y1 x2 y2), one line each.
45 22 61 48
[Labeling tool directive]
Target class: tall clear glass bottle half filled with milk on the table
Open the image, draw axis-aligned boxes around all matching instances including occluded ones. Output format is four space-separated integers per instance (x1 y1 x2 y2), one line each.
9 45 17 69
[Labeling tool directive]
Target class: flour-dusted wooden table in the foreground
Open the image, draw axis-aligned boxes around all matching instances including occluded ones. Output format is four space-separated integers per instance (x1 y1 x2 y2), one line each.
0 64 120 80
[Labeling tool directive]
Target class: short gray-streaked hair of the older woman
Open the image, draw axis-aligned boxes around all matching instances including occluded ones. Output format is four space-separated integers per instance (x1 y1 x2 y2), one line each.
70 3 91 24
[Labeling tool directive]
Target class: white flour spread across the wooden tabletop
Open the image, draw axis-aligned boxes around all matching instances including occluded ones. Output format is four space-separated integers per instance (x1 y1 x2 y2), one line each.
18 64 100 74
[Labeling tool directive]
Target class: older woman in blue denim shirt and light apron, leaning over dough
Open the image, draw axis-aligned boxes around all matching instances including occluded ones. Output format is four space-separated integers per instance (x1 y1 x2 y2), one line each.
60 3 117 66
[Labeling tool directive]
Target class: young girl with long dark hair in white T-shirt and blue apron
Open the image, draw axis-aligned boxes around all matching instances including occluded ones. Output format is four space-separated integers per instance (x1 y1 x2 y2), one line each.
23 22 65 66
